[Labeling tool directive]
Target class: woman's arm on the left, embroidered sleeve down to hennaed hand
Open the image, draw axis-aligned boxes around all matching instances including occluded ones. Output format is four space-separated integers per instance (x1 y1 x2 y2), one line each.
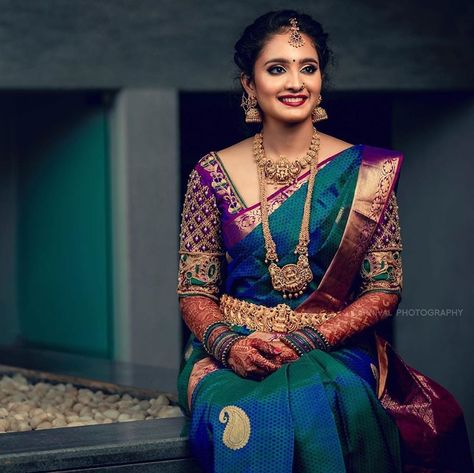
177 169 286 376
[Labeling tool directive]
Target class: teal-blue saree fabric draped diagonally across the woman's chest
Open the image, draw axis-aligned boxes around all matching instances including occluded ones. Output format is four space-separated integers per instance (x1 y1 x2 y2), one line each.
225 147 362 308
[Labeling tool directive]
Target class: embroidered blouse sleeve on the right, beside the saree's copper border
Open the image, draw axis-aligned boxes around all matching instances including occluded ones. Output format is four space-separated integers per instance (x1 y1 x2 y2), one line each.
357 192 403 297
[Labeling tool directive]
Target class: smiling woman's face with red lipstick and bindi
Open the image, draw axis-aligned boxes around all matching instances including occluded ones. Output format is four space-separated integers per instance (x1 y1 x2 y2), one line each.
242 33 322 123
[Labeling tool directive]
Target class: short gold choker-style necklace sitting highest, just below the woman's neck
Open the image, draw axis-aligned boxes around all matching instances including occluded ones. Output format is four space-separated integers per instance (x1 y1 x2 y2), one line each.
254 133 316 185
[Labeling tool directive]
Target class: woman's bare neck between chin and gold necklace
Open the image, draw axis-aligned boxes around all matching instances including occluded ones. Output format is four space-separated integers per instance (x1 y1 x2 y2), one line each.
263 120 313 159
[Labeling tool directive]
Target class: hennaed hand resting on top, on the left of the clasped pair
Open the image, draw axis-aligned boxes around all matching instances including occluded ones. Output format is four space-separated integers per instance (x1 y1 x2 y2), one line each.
227 337 281 379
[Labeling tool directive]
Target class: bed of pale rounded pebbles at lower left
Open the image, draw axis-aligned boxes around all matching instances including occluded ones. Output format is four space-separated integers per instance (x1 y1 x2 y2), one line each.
0 374 183 433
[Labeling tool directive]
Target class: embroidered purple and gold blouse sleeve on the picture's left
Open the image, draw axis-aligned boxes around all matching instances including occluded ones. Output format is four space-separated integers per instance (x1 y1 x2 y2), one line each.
177 169 224 300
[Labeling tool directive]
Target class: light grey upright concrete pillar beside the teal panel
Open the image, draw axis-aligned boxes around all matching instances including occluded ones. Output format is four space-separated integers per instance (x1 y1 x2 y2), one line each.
110 89 181 369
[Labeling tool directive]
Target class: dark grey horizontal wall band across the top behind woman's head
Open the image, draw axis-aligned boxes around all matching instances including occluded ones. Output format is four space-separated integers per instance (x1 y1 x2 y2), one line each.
0 0 474 90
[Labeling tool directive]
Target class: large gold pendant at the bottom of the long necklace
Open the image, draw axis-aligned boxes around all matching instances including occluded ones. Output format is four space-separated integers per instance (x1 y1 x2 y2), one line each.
268 255 313 299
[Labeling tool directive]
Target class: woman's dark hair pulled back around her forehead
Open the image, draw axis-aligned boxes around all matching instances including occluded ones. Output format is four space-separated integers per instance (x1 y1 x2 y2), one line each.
234 10 332 81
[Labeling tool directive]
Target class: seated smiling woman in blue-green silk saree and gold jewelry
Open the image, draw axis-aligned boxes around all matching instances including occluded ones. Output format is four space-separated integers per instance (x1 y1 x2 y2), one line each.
178 10 468 473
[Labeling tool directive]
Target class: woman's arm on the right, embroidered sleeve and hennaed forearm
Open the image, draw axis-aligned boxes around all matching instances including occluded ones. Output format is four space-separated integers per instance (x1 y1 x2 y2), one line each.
282 193 402 351
